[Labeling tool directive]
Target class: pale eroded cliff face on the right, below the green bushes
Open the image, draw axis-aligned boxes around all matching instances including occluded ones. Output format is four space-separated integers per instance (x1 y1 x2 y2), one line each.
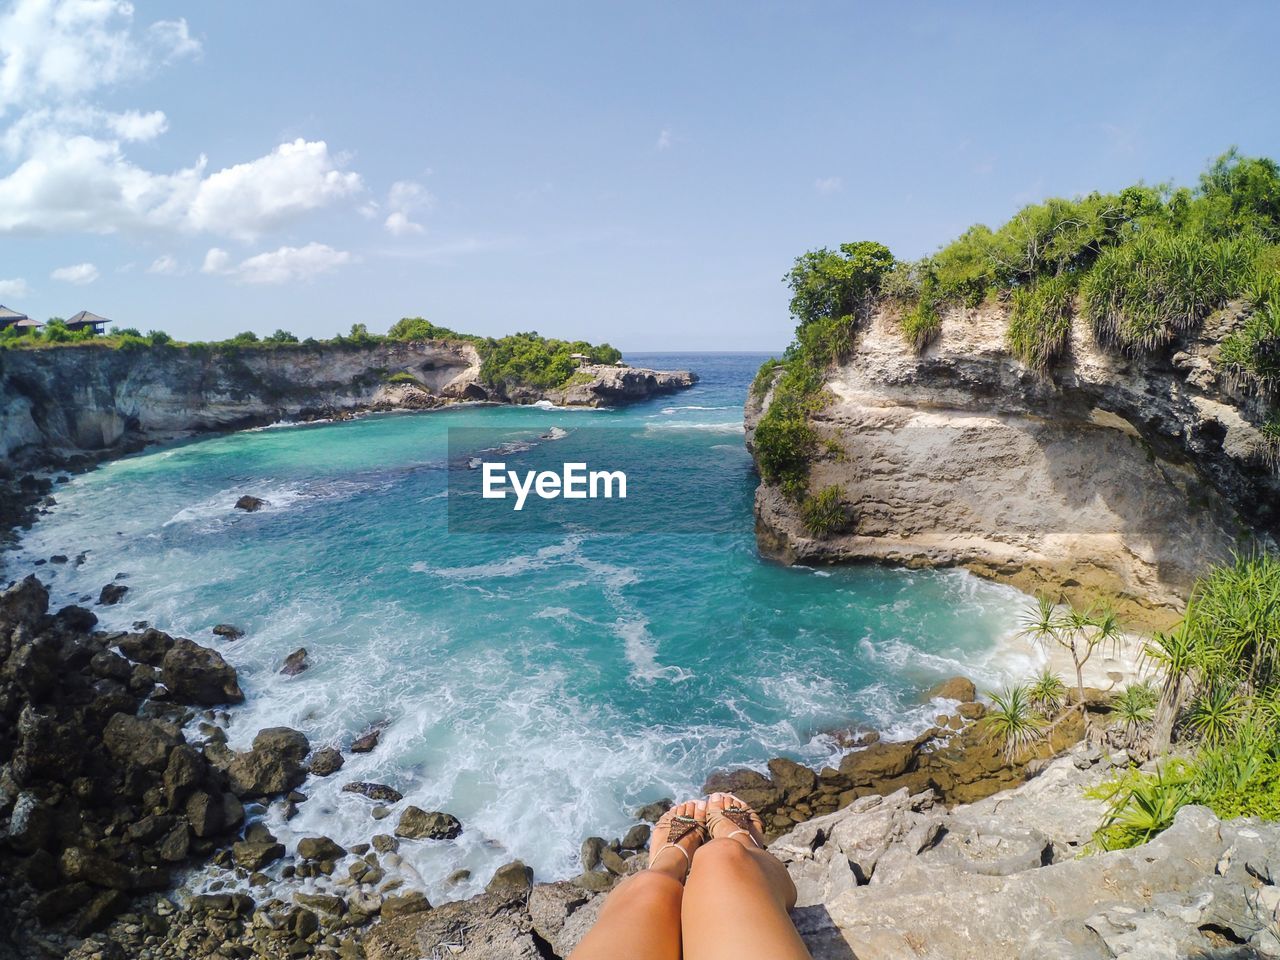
746 306 1280 626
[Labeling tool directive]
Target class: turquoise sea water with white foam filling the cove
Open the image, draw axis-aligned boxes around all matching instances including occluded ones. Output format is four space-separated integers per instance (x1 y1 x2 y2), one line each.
14 355 1032 897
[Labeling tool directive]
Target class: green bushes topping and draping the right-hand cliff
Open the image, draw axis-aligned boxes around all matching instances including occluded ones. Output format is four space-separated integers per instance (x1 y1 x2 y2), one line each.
753 148 1280 512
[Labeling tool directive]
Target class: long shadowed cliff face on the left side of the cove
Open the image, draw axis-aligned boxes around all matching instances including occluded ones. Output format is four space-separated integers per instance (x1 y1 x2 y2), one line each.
0 340 485 462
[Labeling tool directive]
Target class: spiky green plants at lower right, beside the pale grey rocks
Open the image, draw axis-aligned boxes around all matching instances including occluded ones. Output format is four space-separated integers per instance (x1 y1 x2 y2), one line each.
1092 553 1280 850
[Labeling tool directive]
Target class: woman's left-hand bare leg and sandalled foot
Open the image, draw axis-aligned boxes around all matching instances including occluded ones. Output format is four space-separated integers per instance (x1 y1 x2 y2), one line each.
570 800 707 960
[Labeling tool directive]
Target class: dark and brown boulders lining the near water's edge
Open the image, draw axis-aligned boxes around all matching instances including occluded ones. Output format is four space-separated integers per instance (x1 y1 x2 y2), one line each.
0 563 1111 960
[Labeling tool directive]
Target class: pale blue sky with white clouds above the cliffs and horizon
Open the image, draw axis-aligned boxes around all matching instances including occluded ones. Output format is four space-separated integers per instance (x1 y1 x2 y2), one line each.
0 0 1280 351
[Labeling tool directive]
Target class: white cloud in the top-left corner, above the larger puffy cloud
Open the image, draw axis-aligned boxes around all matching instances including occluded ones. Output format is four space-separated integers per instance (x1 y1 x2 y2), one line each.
0 0 200 115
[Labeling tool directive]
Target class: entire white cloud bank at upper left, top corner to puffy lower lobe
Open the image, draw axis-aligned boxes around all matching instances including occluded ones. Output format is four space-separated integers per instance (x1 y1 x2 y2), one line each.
0 0 364 241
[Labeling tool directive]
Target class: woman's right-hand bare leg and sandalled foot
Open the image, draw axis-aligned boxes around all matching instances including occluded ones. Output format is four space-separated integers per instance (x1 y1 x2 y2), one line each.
681 794 810 960
